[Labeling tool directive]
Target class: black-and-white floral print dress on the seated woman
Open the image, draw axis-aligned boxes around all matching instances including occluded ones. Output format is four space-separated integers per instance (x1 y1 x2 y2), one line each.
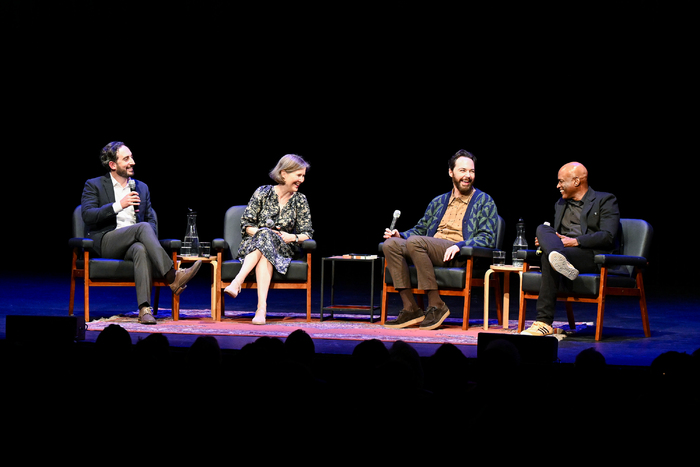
237 185 313 274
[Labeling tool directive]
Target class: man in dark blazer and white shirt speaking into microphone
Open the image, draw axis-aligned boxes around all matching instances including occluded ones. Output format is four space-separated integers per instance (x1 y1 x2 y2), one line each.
81 141 201 324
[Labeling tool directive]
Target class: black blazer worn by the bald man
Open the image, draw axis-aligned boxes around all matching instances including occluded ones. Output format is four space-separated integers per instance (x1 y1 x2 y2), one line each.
554 187 620 255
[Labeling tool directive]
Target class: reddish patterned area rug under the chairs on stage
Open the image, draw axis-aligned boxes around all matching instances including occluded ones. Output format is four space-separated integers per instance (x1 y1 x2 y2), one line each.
87 308 591 345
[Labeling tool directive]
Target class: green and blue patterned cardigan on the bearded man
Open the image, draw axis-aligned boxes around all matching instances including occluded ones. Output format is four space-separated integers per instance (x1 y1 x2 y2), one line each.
401 188 498 248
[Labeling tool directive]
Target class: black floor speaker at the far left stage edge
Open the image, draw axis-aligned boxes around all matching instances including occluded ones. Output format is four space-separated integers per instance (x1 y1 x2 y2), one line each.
5 315 85 344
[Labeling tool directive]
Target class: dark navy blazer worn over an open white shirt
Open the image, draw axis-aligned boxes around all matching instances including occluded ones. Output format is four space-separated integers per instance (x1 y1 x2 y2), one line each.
81 173 158 256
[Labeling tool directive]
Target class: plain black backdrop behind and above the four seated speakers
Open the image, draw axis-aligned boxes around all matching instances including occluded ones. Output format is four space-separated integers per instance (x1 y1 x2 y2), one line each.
5 1 698 296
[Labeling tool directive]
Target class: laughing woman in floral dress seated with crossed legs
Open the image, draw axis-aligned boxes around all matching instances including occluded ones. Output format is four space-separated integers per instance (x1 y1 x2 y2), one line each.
224 154 313 324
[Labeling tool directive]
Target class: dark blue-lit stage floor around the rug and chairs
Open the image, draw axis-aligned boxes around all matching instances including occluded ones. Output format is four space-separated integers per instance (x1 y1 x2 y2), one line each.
0 272 700 366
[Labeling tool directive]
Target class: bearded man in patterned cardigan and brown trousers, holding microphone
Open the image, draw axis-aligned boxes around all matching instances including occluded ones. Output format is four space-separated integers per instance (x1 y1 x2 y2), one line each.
383 149 498 330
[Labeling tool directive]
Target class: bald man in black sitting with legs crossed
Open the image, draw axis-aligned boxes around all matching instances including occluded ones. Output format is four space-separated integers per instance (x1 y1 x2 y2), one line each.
522 162 620 336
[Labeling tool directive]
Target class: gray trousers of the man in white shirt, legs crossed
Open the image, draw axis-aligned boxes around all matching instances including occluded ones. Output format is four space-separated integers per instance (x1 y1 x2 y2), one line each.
101 222 173 307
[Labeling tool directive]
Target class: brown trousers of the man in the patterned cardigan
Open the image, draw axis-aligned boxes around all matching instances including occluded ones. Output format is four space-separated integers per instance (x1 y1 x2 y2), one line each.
382 235 456 290
